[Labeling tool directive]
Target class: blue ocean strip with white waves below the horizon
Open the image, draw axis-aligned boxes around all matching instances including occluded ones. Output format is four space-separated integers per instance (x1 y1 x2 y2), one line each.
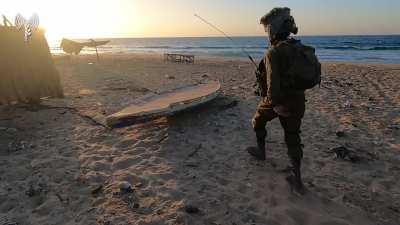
50 35 400 64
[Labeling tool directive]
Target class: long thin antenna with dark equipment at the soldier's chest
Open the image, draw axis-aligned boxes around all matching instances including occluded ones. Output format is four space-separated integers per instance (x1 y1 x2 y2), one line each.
194 14 265 96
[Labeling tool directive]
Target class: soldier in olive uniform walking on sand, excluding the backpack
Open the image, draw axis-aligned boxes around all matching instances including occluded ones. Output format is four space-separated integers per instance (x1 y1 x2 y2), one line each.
247 8 305 194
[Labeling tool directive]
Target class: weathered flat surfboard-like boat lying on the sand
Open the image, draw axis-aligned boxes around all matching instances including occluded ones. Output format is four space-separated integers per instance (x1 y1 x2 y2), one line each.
106 81 221 127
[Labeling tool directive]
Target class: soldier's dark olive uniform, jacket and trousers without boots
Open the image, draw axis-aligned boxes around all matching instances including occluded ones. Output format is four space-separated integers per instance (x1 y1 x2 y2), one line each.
252 40 305 160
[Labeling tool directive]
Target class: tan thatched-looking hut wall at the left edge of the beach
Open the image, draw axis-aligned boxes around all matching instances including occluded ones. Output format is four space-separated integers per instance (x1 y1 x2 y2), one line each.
0 25 63 105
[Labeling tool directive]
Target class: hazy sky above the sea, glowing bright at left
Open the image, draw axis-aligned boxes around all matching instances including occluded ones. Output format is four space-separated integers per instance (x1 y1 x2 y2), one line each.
0 0 400 38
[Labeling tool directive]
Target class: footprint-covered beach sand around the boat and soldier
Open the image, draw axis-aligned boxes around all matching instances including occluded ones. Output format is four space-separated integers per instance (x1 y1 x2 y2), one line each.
0 54 400 225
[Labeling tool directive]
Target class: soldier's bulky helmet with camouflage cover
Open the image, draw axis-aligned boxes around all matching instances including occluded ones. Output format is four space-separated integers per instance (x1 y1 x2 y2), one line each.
260 7 298 34
